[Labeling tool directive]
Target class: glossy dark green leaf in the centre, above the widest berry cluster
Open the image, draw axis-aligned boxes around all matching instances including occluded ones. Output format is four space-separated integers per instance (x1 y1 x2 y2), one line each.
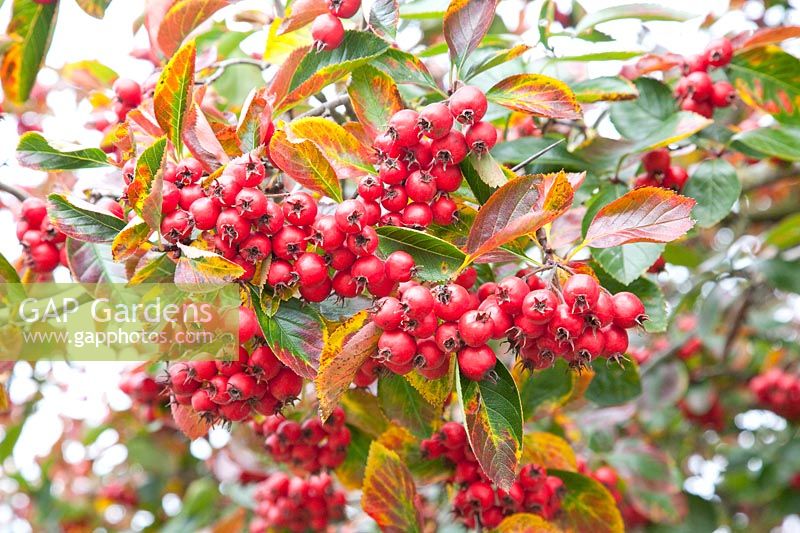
375 226 466 281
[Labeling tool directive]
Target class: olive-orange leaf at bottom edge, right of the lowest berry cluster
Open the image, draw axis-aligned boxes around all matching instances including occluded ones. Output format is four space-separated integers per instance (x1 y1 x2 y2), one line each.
547 469 625 533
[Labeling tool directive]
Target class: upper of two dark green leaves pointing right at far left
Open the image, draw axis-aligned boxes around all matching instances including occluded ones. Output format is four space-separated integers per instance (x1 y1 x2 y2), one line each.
17 131 111 170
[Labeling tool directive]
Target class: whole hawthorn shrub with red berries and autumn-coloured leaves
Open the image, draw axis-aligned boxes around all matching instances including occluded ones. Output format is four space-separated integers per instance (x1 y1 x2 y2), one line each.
0 0 800 533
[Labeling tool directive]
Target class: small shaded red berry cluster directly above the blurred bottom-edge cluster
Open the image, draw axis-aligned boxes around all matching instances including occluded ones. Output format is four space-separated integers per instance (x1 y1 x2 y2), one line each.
253 407 350 474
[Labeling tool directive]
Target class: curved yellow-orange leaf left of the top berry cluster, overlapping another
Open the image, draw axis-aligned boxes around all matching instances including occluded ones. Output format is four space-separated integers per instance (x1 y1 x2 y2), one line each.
286 117 375 180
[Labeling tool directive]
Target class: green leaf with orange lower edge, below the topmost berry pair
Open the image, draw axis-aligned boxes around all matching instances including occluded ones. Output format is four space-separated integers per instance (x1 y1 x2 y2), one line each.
273 31 389 115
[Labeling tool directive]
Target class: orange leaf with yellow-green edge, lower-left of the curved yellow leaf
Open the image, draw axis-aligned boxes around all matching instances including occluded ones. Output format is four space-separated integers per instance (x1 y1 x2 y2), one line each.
269 130 342 202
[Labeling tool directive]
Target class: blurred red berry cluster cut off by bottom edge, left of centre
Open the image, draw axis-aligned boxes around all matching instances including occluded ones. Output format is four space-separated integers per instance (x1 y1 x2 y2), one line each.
250 472 347 533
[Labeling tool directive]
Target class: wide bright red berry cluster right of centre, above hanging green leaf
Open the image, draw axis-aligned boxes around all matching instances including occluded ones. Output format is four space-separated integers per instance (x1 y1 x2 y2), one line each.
372 269 647 381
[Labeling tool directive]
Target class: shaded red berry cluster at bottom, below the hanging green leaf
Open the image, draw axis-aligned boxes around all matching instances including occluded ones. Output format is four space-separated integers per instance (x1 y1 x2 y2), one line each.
421 422 565 528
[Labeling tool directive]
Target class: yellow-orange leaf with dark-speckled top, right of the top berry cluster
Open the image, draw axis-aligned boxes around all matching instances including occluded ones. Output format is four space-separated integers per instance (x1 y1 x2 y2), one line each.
486 74 582 119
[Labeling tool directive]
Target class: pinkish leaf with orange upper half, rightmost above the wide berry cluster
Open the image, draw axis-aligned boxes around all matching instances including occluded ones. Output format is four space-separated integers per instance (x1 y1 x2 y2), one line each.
584 187 696 248
